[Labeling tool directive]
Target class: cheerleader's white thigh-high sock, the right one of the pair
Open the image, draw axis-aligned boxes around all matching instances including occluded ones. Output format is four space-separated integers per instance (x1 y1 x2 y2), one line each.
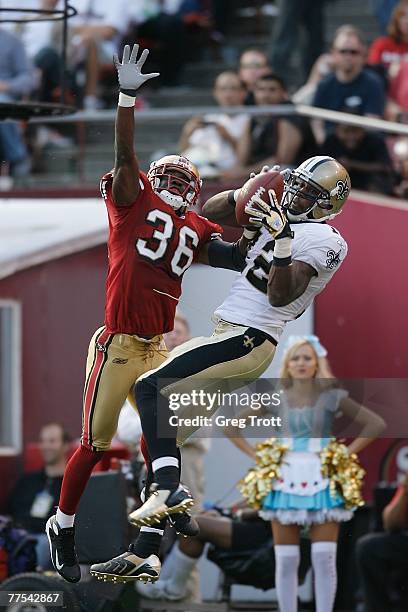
312 542 337 612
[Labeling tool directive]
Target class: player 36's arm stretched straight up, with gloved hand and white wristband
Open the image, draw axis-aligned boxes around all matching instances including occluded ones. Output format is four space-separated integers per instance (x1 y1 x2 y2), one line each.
112 45 159 206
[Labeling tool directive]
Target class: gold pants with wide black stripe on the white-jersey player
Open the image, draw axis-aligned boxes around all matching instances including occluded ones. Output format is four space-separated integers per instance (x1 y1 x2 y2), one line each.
136 321 277 444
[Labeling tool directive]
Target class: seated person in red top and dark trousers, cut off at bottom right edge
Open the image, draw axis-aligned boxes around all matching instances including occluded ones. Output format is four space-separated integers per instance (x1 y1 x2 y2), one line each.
356 473 408 612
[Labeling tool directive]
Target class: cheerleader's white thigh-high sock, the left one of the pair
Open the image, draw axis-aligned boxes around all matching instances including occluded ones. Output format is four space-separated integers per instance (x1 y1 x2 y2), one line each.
274 544 300 612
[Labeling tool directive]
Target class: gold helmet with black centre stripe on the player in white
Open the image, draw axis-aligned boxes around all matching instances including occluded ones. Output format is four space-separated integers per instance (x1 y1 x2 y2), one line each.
282 155 351 223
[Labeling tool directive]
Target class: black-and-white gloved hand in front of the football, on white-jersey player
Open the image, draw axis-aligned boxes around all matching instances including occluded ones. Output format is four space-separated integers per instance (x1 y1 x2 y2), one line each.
245 189 292 238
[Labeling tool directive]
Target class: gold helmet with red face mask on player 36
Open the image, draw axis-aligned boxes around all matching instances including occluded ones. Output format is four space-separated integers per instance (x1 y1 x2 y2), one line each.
147 155 202 210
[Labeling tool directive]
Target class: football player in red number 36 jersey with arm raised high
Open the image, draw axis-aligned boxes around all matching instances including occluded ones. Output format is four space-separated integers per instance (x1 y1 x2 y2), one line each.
46 45 255 582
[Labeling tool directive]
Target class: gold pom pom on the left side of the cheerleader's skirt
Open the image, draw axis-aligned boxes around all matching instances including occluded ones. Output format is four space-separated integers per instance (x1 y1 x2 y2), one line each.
238 438 288 510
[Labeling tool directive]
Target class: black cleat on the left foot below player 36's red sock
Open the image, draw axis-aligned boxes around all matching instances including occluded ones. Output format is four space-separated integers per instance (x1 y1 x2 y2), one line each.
45 515 81 582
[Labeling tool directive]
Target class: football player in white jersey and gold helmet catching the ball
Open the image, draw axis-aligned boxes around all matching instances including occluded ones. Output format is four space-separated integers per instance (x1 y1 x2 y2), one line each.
91 156 350 582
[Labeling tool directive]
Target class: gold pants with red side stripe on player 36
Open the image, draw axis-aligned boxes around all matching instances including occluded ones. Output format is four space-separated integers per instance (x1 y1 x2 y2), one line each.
81 327 168 451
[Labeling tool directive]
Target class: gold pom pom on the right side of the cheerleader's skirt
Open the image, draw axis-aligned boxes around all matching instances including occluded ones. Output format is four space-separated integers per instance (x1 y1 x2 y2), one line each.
320 438 365 509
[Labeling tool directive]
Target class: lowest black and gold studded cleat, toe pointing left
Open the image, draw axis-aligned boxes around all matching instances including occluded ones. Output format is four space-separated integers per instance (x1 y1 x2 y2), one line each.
90 551 161 583
